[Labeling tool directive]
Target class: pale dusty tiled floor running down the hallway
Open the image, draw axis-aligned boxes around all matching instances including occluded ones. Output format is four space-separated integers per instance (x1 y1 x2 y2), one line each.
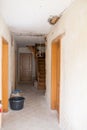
2 85 60 130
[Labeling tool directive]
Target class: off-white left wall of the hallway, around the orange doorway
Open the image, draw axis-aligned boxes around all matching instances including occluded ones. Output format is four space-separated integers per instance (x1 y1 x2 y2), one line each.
0 16 15 99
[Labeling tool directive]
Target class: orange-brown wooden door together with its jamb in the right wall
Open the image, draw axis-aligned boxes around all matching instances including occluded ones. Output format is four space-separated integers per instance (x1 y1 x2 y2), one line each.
51 40 60 117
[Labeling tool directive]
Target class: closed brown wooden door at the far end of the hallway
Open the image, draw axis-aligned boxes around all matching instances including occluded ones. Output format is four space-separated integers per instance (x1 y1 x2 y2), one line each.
20 53 32 82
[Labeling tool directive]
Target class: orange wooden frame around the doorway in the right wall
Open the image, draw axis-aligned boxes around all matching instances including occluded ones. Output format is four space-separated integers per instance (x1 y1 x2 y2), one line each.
51 33 64 119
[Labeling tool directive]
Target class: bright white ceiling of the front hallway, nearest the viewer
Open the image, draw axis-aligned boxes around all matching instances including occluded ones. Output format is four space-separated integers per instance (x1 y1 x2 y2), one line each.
0 0 72 34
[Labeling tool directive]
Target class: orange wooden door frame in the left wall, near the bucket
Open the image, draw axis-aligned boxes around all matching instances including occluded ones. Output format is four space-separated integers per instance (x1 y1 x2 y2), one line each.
2 38 8 112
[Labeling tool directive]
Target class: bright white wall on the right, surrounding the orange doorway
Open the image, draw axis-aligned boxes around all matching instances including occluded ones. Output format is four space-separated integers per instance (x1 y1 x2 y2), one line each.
46 0 87 130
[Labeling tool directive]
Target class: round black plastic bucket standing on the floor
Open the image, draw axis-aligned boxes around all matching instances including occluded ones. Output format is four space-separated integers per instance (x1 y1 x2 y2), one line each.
9 97 25 110
